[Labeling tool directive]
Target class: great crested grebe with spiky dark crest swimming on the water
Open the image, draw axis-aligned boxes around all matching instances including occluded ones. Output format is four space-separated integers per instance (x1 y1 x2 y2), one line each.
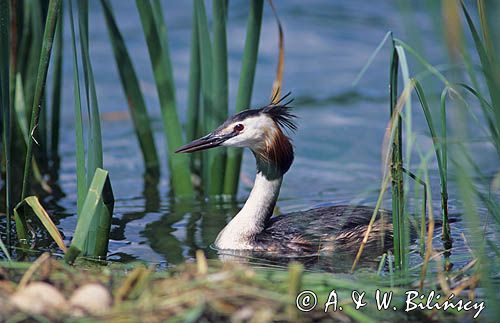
176 95 392 254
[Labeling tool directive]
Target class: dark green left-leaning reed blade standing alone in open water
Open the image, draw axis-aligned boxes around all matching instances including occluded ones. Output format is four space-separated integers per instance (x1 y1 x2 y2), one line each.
101 0 160 179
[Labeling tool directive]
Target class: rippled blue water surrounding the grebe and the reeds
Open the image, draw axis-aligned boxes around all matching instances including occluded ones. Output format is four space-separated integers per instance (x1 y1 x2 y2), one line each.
8 0 498 266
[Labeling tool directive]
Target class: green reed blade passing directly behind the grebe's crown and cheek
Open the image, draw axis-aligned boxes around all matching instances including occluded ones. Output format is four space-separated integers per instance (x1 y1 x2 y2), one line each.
224 0 264 196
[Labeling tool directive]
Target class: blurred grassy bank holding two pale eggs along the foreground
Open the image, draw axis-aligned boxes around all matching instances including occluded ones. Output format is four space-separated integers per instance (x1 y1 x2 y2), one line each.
0 251 484 322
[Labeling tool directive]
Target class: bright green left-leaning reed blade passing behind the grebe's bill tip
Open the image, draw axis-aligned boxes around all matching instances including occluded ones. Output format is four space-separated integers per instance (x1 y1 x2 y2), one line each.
136 0 194 196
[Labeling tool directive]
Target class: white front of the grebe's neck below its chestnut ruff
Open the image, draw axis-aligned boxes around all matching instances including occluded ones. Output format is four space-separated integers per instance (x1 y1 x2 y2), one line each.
215 171 283 249
